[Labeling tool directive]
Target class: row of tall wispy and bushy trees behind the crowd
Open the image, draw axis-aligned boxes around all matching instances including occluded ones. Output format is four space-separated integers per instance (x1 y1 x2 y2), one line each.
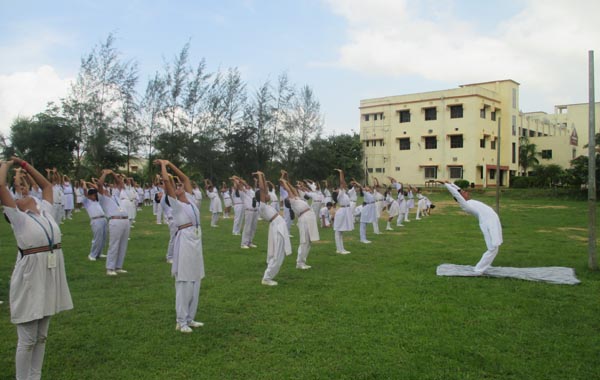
2 34 363 182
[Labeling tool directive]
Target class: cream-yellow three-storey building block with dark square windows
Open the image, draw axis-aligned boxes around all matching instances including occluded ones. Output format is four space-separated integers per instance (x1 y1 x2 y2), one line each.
360 80 519 187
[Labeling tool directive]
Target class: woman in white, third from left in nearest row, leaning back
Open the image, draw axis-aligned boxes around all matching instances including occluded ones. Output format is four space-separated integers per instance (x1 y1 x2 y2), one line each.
254 172 292 286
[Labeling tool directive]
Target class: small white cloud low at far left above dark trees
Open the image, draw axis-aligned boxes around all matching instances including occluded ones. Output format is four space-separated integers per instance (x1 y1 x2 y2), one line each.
0 65 72 135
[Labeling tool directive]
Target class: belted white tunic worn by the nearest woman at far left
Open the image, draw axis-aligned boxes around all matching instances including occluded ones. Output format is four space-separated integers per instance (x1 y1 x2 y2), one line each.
4 200 73 323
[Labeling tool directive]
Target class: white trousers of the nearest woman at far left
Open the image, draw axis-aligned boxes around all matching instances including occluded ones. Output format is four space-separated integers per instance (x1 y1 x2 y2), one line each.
15 317 50 380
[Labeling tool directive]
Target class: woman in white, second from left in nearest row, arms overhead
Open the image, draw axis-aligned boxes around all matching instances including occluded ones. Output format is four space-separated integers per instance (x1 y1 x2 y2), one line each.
154 160 204 333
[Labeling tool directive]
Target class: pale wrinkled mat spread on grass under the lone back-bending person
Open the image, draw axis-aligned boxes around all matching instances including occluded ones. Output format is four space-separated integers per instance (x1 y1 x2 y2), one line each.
436 264 580 285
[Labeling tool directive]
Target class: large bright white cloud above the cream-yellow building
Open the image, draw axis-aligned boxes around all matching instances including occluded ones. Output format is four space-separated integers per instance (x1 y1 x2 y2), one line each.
326 0 600 111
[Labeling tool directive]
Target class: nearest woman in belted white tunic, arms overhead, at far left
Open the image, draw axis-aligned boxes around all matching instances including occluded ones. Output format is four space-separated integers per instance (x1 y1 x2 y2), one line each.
0 157 73 379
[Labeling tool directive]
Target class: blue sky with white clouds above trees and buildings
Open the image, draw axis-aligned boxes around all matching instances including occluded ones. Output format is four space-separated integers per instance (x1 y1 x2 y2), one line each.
0 0 600 135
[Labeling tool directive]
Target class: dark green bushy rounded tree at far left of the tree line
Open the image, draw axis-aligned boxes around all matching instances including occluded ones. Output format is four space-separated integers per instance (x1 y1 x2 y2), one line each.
8 113 77 172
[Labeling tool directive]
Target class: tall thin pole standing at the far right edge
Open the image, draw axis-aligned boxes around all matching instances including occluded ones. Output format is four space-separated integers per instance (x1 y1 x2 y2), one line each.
588 50 598 270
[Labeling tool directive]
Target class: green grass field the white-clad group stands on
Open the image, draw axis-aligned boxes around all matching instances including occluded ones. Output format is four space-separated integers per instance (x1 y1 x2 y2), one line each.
0 191 600 380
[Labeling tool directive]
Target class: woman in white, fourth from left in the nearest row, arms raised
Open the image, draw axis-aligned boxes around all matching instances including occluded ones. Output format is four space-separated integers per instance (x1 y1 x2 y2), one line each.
279 170 321 269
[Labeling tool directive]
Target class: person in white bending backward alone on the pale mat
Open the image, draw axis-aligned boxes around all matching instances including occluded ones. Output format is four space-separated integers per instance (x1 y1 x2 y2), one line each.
437 180 502 274
